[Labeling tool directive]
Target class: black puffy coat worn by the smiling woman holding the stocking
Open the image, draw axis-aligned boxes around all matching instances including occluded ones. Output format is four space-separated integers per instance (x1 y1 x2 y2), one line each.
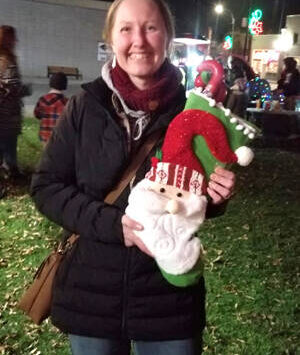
32 79 205 340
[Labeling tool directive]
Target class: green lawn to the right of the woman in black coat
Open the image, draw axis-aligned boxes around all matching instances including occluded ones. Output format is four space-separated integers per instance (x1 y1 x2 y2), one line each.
202 150 300 355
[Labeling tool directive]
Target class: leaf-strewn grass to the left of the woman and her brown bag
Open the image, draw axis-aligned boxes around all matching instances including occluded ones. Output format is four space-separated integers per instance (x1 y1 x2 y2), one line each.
0 118 70 355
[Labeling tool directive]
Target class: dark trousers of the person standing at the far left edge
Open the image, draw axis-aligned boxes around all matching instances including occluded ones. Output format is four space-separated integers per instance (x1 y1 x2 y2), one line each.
0 135 18 170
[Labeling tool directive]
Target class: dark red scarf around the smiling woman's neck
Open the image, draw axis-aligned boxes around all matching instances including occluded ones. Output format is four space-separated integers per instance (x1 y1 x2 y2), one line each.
111 60 181 112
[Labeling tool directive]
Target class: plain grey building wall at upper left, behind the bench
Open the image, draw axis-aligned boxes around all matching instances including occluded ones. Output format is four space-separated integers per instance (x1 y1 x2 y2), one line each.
0 0 111 80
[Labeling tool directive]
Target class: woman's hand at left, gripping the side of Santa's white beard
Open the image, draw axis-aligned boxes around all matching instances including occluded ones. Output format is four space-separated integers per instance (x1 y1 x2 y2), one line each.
121 214 153 257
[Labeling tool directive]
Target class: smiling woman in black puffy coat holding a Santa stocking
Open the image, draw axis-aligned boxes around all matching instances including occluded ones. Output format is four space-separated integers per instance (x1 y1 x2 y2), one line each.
32 0 234 355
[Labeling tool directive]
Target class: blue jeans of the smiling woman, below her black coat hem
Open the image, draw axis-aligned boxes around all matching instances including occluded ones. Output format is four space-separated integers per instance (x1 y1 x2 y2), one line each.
69 334 201 355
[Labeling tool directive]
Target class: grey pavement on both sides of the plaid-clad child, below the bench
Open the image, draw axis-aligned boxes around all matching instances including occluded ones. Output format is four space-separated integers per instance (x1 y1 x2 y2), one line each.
22 76 92 117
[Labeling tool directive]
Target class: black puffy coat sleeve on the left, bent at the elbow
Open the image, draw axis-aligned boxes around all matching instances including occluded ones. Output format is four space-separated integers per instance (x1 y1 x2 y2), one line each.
31 97 123 243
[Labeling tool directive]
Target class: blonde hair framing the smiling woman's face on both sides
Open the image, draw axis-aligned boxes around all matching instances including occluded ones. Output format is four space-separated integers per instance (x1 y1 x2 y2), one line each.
103 0 175 49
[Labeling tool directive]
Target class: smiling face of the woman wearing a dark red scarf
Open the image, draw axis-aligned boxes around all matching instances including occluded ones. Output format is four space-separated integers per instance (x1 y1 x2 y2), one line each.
111 0 168 89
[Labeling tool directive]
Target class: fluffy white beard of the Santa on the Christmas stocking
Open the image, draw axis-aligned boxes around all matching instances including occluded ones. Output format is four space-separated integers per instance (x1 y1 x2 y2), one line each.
126 179 207 275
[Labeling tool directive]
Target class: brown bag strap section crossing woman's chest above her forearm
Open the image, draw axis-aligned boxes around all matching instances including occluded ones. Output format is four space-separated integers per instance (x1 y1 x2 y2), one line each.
104 131 162 204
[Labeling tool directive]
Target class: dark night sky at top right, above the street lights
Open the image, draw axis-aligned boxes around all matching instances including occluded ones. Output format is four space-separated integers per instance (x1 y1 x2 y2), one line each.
102 0 300 38
